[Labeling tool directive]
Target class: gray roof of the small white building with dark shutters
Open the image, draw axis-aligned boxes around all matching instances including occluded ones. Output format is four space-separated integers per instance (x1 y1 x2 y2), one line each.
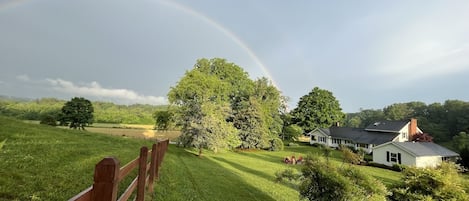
392 142 459 157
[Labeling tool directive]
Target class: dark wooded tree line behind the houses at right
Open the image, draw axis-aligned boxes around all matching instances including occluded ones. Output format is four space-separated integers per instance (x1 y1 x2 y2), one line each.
344 100 469 142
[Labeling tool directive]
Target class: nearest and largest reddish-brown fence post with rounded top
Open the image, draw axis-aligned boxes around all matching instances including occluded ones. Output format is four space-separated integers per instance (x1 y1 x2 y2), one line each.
91 157 120 201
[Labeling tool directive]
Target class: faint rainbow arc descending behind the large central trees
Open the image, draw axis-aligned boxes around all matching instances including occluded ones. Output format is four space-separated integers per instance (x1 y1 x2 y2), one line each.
158 0 280 90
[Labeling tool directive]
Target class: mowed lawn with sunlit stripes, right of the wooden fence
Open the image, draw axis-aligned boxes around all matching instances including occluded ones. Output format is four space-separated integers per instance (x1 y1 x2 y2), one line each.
154 142 401 201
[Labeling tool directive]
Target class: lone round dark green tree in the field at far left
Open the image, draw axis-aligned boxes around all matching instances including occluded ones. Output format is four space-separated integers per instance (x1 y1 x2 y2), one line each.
59 97 94 130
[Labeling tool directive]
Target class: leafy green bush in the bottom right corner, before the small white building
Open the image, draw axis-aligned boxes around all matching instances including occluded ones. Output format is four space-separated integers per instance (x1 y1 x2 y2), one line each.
390 163 469 201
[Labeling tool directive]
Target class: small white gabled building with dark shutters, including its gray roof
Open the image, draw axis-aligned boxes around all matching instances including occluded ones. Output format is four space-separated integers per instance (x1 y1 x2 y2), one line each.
373 142 459 167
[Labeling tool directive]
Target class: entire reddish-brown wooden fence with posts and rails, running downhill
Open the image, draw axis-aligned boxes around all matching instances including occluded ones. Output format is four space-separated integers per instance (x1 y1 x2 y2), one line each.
69 140 169 201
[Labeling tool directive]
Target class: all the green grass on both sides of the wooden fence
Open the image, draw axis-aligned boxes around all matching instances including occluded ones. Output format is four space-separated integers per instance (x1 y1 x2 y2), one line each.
0 117 400 201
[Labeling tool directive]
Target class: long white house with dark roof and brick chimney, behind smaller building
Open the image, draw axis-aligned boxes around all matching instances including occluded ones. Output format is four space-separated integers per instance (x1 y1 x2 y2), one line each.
309 119 422 153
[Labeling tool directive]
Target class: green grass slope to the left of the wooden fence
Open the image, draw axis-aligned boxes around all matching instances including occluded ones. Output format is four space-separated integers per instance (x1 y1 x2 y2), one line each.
0 116 152 200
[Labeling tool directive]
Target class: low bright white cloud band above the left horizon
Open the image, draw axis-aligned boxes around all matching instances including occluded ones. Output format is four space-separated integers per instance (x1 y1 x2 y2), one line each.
46 79 168 105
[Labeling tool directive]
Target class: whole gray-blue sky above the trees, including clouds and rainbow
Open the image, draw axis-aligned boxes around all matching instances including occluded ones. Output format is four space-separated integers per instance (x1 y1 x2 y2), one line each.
0 0 469 113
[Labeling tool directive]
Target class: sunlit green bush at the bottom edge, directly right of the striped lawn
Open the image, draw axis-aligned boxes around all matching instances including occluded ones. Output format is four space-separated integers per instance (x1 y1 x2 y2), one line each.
299 156 387 200
